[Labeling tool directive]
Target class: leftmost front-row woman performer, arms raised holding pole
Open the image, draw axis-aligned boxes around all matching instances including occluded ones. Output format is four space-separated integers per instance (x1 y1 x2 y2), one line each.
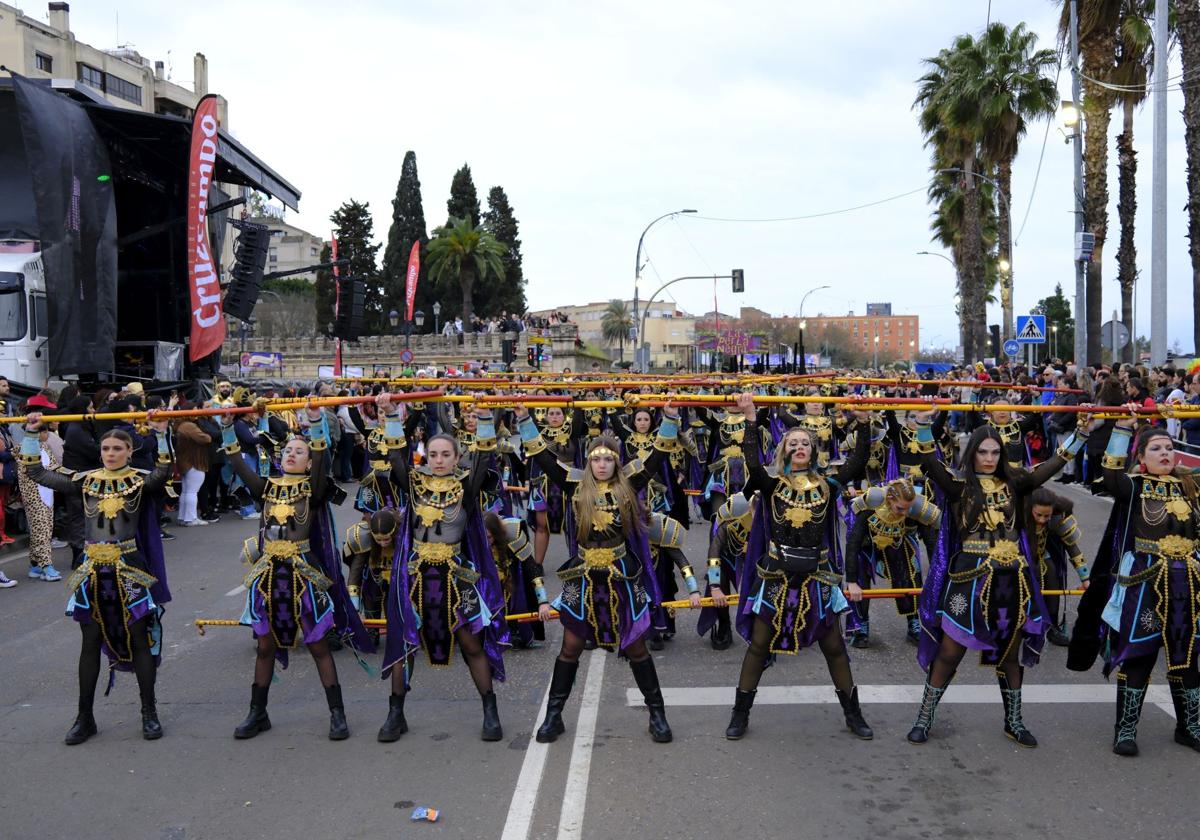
18 412 173 745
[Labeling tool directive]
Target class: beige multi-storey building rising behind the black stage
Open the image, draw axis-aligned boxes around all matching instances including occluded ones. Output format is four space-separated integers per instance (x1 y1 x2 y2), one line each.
0 2 229 123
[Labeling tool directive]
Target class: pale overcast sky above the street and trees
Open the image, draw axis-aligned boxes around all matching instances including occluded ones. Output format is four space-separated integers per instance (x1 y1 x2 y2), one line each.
63 0 1192 349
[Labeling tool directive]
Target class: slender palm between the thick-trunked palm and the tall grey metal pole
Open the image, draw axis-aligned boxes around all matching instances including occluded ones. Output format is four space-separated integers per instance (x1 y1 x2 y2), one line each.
1112 0 1154 362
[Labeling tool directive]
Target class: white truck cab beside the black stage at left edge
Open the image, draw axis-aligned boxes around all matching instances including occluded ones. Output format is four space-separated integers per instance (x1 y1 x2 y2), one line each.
0 240 50 388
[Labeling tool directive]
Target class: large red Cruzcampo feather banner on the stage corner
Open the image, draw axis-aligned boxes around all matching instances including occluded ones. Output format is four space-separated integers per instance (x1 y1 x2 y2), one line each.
187 94 224 361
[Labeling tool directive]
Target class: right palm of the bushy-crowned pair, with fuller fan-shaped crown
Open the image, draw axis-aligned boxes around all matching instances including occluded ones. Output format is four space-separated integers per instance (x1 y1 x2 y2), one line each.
959 22 1058 338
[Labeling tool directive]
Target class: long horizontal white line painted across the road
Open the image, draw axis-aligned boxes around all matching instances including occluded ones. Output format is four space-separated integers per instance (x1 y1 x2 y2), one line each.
625 683 1175 716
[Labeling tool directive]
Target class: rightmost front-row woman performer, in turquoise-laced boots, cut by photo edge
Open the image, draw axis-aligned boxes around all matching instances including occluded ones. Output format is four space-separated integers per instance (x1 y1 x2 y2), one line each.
1089 417 1200 756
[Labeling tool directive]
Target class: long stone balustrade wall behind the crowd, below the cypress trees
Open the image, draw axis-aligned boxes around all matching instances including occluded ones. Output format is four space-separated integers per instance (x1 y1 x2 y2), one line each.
222 324 592 379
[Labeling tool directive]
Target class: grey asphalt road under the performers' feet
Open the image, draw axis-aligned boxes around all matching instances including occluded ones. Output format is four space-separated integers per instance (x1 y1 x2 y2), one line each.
0 480 1200 840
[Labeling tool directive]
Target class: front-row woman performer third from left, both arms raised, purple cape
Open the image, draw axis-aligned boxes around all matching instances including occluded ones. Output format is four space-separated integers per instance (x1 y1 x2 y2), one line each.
376 394 509 743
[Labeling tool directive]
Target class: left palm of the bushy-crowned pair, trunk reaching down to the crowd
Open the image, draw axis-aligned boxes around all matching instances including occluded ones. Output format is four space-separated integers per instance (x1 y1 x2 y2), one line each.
913 35 988 361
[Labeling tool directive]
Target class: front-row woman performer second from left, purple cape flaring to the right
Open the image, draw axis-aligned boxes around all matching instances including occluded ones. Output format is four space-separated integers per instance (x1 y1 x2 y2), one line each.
222 408 372 740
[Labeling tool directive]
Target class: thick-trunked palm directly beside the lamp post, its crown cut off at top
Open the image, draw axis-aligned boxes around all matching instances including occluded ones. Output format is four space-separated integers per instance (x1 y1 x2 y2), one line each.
1058 0 1126 362
